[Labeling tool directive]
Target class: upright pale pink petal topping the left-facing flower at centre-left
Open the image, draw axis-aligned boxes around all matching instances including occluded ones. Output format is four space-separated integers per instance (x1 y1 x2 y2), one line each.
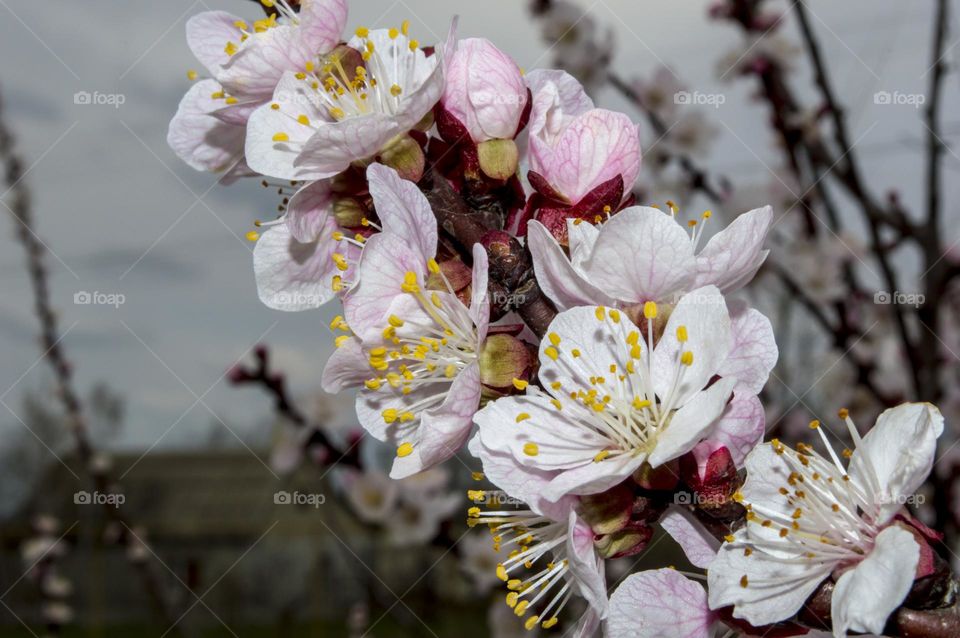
367 164 437 263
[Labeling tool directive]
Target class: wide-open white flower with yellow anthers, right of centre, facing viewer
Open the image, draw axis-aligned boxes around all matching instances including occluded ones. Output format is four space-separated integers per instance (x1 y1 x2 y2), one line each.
475 286 737 500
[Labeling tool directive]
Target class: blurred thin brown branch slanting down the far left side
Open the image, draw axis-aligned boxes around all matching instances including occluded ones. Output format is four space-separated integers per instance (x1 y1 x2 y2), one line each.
0 86 193 636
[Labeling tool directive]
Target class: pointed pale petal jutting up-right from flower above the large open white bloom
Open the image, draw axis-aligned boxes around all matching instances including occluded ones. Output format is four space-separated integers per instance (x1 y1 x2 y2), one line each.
695 206 773 293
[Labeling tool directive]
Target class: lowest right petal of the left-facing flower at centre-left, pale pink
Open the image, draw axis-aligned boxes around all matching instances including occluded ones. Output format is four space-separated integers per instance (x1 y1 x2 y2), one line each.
420 362 480 467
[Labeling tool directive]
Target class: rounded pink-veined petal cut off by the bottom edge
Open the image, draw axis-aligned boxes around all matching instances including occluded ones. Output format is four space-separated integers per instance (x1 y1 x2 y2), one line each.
607 569 715 638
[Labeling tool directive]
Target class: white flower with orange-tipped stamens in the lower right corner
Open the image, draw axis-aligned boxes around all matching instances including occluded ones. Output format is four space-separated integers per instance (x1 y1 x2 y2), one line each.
708 403 943 637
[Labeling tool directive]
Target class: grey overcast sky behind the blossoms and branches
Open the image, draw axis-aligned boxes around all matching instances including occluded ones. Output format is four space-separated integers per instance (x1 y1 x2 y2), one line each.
0 0 960 456
